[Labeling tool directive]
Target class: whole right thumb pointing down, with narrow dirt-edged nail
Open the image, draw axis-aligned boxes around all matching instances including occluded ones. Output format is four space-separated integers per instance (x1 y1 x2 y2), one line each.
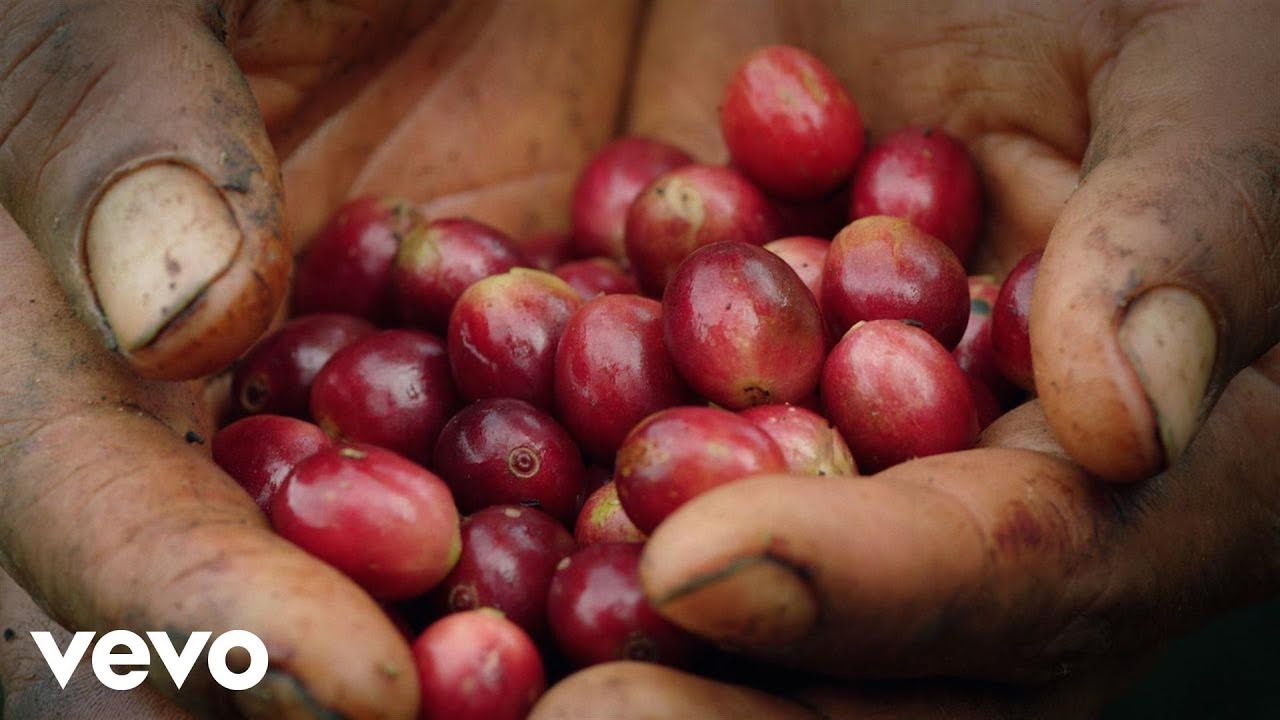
1030 3 1280 480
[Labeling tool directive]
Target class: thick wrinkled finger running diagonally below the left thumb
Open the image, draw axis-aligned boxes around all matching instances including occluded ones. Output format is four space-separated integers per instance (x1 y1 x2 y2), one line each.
0 214 417 717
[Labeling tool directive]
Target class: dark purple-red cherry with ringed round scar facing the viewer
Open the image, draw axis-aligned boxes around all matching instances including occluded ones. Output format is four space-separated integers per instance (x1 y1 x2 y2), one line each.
431 397 586 525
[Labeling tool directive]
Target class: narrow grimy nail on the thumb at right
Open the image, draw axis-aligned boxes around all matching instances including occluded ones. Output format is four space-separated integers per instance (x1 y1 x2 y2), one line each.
1120 287 1217 465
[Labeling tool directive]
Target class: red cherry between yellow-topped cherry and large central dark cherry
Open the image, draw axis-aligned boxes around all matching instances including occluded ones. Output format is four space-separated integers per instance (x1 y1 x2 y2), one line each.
556 295 689 456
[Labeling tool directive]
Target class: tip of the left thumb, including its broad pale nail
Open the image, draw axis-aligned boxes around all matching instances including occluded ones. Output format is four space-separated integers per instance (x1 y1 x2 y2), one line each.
84 163 291 379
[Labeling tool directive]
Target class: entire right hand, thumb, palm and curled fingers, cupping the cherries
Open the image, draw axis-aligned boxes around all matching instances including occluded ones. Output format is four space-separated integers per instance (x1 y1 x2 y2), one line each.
535 4 1280 719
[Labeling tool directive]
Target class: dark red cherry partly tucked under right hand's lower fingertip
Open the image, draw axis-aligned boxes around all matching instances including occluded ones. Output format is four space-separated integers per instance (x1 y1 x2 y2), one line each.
547 542 699 667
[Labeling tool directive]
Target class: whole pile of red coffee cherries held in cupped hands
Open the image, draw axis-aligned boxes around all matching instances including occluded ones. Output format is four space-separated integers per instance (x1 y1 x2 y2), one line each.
212 46 1038 720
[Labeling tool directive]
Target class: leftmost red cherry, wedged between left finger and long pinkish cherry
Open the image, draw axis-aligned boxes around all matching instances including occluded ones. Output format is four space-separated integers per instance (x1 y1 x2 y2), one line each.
210 415 329 512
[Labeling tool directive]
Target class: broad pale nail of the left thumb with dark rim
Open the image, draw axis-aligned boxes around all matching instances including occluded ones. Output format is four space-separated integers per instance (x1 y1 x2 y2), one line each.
84 164 241 352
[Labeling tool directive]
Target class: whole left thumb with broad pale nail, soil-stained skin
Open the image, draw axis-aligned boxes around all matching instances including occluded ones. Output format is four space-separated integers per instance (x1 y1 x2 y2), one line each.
0 0 291 379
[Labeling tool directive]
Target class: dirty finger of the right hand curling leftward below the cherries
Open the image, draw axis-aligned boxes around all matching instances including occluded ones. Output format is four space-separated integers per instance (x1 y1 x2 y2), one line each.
641 340 1280 679
